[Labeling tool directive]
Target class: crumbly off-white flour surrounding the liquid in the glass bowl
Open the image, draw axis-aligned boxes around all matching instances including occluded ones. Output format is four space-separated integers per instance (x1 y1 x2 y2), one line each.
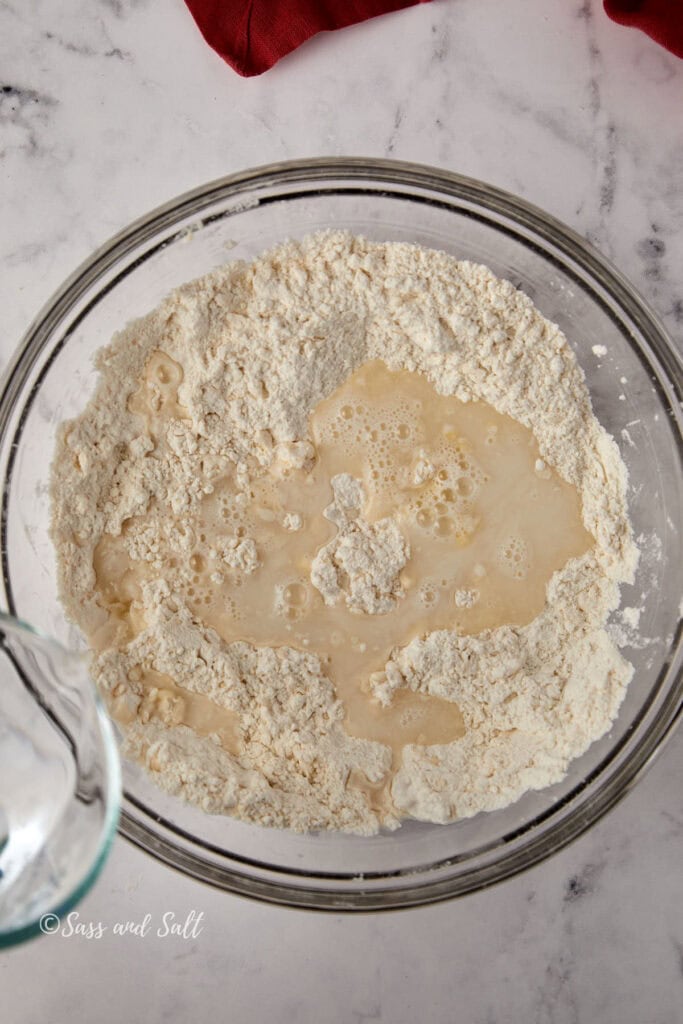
51 232 637 834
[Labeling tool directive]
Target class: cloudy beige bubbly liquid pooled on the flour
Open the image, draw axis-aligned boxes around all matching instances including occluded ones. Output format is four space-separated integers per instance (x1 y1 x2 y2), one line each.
91 351 592 770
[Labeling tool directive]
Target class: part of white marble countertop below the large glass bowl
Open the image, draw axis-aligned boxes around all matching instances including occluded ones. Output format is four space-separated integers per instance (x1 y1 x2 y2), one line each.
0 738 683 1024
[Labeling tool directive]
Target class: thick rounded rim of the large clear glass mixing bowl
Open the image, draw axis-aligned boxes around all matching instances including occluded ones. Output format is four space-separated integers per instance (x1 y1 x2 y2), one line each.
0 157 683 912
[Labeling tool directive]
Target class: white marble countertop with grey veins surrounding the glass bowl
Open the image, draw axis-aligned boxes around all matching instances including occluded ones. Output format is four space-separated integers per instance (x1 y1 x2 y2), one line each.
0 0 683 1024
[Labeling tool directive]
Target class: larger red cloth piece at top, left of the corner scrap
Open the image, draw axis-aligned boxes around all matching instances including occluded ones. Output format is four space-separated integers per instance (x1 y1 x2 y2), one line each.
185 0 429 76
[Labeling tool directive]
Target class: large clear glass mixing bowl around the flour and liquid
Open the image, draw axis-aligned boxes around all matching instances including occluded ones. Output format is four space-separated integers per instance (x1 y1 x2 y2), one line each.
0 159 683 910
